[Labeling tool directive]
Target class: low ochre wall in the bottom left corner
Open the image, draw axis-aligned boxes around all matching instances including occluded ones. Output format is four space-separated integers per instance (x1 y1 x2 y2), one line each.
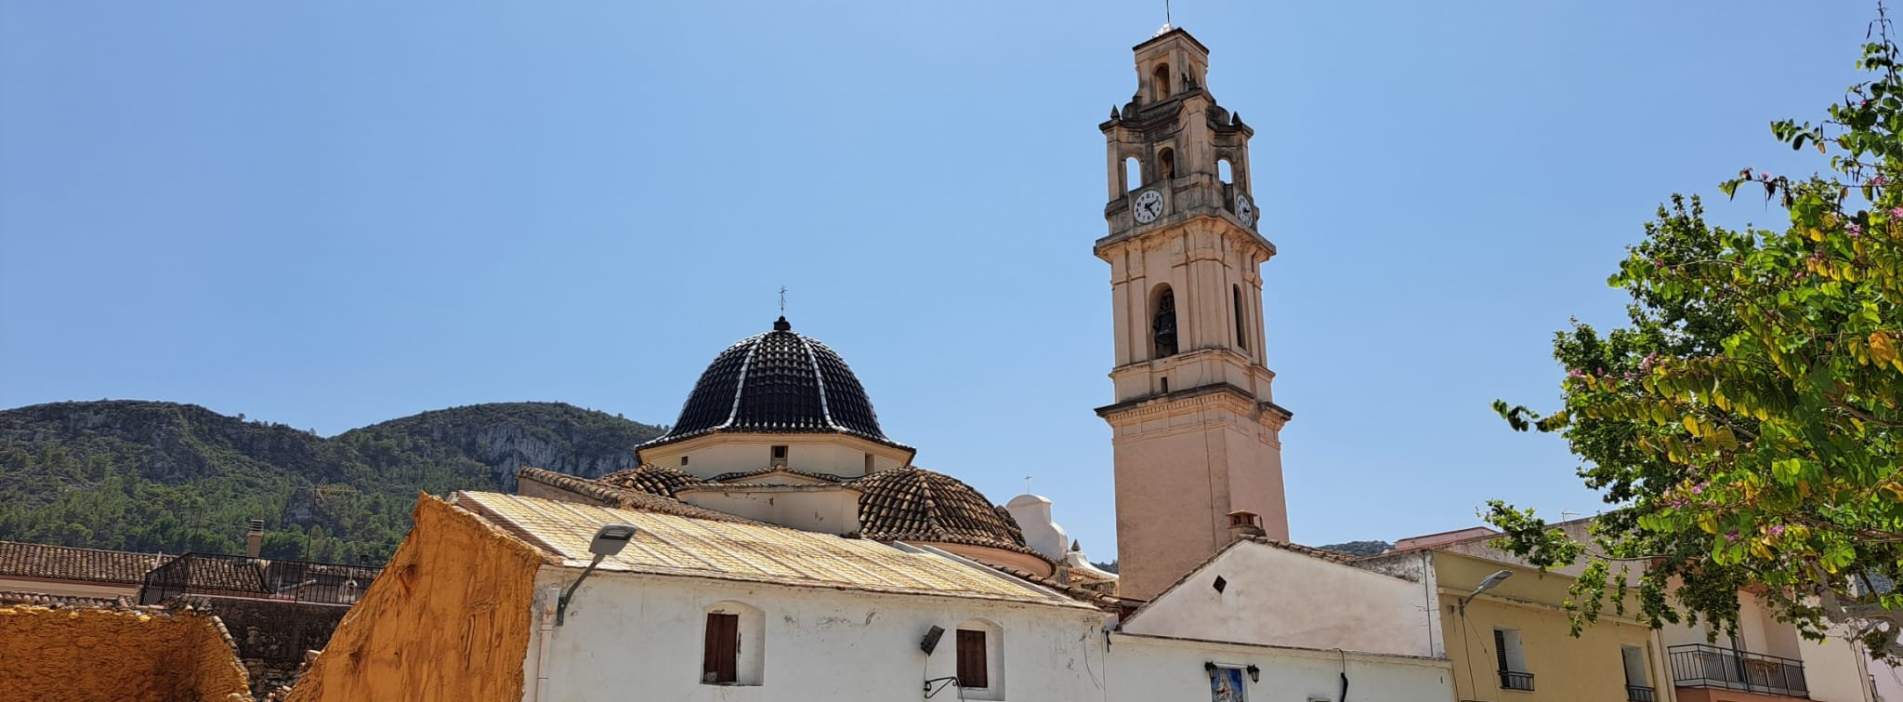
0 607 251 702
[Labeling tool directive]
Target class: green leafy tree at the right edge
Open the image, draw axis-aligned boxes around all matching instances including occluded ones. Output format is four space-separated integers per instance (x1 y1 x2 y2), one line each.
1488 10 1903 656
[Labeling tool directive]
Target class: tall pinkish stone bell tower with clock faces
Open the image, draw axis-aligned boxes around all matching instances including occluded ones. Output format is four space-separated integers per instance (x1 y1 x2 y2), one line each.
1094 29 1290 599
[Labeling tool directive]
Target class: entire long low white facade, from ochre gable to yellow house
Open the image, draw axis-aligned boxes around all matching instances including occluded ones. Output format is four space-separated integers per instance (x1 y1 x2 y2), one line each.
523 569 1452 702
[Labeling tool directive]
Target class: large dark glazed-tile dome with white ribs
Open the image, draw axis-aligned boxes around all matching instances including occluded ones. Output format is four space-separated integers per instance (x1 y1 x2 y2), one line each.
647 318 893 445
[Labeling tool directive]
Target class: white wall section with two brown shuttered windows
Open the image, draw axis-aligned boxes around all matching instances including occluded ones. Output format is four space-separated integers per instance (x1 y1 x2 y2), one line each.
525 569 1106 702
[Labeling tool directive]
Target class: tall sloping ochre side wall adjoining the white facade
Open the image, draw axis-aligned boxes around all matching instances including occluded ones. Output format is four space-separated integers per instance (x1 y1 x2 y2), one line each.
287 495 542 702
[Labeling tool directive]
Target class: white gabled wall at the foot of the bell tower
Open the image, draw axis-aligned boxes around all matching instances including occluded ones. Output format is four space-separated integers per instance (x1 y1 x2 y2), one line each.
1125 542 1439 656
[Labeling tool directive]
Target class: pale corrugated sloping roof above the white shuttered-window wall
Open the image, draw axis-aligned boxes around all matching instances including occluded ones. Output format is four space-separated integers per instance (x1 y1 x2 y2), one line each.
453 493 1087 609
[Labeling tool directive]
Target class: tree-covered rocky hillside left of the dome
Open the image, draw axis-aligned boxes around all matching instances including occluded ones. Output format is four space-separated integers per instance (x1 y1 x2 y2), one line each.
0 401 660 561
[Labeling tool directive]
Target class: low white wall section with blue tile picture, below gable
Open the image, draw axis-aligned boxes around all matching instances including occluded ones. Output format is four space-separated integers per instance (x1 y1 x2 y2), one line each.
1106 634 1454 702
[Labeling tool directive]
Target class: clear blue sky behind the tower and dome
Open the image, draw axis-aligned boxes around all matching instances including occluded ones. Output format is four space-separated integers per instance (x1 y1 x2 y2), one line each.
0 0 1874 557
